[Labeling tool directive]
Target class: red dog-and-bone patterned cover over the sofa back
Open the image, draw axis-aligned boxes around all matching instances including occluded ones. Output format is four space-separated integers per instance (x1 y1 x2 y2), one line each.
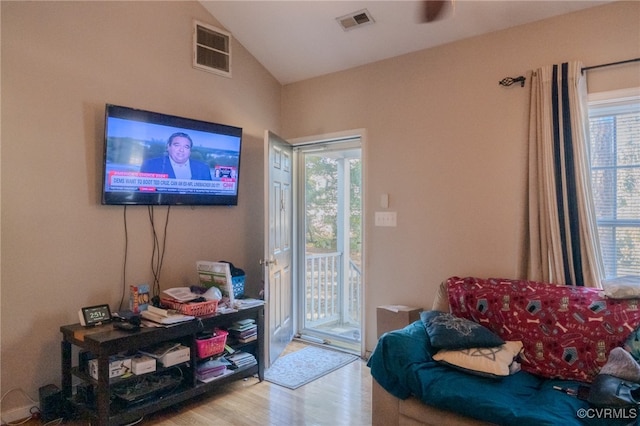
447 277 640 382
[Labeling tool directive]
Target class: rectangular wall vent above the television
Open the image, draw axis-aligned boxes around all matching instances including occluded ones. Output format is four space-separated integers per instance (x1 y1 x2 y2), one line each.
193 21 231 77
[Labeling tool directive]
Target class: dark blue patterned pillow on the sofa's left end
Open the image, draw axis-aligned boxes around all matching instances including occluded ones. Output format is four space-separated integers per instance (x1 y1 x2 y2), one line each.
420 311 504 349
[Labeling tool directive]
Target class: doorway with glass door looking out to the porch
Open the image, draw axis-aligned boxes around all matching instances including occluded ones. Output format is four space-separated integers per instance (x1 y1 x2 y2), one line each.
294 134 364 355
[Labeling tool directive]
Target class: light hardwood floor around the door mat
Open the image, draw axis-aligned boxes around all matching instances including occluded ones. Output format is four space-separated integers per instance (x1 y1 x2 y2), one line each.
31 342 371 426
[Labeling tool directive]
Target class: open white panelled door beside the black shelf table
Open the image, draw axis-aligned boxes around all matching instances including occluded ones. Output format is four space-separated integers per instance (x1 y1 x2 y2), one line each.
263 131 294 367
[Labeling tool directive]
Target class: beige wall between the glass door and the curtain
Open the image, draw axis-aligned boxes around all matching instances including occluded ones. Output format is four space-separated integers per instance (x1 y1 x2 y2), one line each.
282 2 640 350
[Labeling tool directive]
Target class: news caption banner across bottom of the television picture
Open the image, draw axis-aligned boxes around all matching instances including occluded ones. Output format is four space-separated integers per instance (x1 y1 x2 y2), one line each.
108 171 237 192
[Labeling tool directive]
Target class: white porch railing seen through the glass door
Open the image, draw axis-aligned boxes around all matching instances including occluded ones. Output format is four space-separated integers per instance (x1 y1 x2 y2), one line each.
305 252 362 328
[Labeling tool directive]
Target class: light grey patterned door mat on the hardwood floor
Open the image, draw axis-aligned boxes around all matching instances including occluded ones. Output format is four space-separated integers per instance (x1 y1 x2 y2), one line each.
264 346 358 389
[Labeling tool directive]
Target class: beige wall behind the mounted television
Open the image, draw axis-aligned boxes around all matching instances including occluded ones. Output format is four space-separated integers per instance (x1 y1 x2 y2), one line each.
1 1 281 414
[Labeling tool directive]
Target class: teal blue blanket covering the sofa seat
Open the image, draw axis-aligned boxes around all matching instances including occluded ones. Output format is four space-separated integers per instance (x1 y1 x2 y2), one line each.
367 321 638 426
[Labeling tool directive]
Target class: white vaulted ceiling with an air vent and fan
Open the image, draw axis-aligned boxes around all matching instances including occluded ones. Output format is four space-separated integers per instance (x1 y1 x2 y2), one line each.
200 0 610 84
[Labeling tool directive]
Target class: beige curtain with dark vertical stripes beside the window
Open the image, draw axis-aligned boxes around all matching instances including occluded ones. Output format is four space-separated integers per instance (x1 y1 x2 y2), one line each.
518 62 604 288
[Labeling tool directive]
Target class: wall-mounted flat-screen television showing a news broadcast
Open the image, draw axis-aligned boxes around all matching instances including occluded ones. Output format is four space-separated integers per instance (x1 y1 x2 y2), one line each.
102 104 242 205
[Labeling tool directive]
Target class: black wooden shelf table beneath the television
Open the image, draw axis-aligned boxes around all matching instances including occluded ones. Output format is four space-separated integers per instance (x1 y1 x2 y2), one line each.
60 306 264 425
